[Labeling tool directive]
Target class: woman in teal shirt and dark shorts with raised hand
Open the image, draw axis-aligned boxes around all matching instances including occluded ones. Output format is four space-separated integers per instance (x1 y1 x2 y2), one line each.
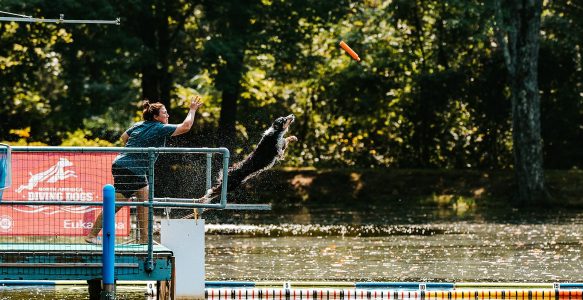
85 95 202 244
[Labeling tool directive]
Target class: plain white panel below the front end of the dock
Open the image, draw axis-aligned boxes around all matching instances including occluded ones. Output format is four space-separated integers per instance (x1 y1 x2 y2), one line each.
160 219 205 299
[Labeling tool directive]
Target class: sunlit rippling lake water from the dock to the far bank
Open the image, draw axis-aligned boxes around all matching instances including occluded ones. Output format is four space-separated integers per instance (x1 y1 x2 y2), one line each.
0 205 583 299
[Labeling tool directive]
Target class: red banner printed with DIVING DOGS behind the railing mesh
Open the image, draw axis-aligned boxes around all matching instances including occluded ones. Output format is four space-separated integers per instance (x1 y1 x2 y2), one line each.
0 152 130 236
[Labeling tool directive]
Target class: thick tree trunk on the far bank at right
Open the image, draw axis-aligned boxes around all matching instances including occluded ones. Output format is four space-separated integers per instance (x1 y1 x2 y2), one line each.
496 0 547 205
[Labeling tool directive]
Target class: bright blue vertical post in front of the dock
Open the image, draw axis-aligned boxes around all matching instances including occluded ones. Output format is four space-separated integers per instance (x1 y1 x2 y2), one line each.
101 184 115 300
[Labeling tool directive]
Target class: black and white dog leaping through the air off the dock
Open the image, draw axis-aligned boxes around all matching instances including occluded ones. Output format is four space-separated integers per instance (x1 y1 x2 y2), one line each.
201 114 298 203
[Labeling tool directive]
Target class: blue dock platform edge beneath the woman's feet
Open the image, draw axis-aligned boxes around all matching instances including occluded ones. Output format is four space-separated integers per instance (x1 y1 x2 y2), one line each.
0 243 174 281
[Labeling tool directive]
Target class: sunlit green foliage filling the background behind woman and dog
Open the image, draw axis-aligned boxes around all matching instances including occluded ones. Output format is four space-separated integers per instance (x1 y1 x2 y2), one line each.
0 0 583 169
